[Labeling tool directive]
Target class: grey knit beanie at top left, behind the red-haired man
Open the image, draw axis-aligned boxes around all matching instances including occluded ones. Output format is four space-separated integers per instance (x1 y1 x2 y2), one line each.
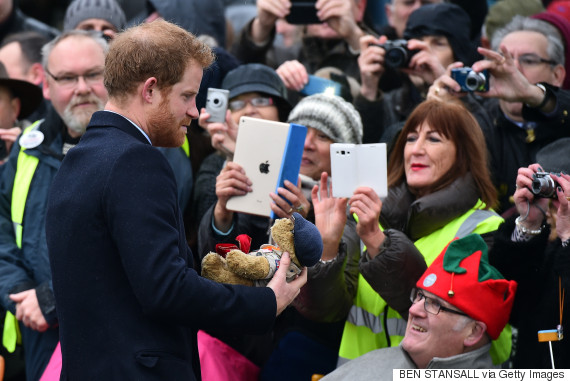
63 0 127 31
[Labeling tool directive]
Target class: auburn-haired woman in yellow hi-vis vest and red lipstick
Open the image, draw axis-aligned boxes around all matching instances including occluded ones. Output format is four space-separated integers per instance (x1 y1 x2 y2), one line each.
339 101 511 365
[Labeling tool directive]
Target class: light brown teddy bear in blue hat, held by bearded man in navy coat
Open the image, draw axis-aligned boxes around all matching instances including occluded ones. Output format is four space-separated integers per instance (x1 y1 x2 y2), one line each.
202 213 323 287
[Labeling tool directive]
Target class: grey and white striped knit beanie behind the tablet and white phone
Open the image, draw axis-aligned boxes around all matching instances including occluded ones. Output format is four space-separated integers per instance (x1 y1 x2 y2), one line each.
287 94 362 144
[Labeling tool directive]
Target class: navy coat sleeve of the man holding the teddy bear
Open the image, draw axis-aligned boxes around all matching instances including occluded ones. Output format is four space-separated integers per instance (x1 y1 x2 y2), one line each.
103 145 276 333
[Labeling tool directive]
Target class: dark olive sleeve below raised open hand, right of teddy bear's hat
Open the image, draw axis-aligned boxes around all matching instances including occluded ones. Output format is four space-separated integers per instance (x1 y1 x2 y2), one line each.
293 214 360 322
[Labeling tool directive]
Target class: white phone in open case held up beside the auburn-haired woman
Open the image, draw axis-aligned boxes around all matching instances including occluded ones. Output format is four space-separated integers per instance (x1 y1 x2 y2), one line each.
330 143 388 198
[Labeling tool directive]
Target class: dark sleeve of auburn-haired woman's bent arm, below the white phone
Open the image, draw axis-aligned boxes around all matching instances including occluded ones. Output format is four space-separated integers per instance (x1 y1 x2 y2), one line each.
360 229 427 317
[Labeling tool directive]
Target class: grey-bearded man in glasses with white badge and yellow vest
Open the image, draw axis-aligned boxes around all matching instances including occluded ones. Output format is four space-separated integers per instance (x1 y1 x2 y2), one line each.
0 30 108 380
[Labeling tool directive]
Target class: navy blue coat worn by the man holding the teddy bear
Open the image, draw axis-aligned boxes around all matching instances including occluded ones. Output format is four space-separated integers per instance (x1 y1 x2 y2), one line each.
46 111 276 380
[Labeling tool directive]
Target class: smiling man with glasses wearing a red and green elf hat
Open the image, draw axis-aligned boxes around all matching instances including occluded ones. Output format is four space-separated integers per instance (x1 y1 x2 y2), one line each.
323 234 517 381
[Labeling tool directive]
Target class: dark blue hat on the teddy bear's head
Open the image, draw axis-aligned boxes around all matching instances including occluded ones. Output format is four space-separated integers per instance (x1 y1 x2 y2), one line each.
293 213 323 267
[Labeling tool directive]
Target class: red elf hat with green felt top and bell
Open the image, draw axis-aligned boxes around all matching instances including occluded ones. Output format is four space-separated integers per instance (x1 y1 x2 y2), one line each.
416 234 517 340
